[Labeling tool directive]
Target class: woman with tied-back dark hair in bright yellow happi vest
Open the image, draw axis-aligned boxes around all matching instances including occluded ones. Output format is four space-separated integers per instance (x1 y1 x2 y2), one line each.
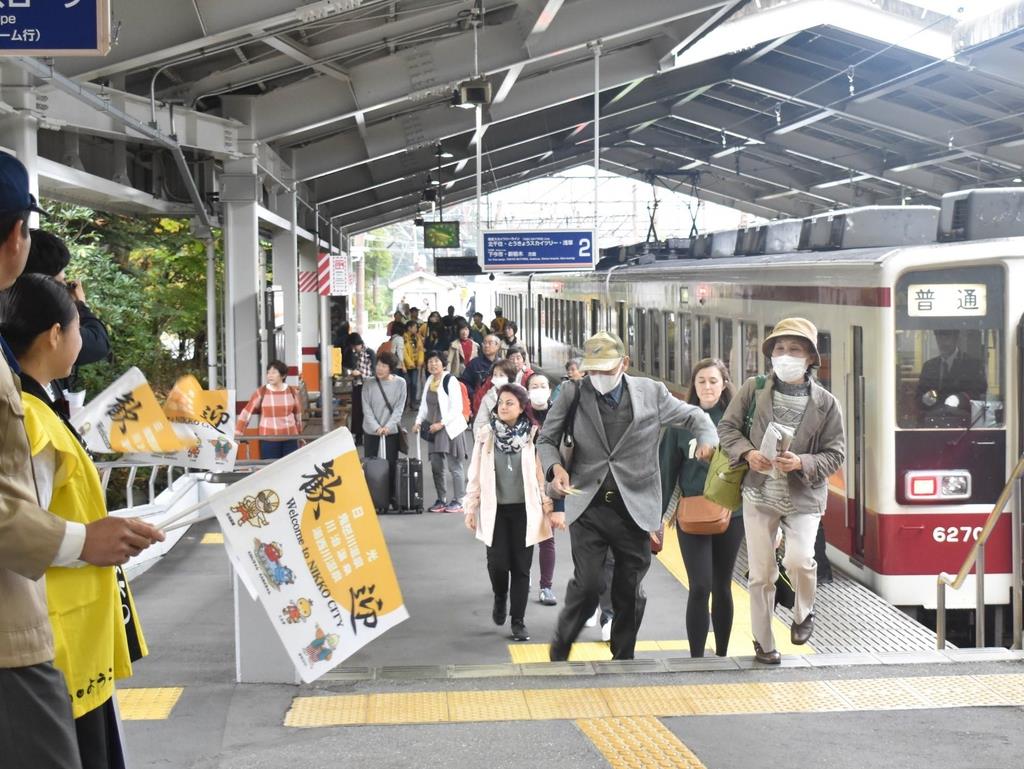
0 274 146 769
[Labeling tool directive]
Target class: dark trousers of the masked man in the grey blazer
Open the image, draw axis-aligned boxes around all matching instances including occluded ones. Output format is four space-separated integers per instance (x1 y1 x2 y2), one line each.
551 504 650 660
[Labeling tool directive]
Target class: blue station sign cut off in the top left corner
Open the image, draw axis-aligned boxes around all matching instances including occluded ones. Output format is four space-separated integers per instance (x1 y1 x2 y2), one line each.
0 0 111 56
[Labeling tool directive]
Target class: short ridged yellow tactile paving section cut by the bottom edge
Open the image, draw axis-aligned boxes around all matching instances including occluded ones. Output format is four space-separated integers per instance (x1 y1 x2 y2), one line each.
577 717 705 769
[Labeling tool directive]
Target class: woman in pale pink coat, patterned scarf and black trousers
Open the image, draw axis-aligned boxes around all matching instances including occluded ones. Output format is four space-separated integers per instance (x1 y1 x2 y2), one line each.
463 384 565 641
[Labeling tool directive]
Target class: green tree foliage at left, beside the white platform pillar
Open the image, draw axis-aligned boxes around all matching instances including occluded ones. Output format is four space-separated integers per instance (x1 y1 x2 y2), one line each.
42 202 223 394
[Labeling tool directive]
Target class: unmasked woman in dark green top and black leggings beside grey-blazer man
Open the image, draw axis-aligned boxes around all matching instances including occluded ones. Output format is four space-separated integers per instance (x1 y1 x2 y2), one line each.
658 357 743 656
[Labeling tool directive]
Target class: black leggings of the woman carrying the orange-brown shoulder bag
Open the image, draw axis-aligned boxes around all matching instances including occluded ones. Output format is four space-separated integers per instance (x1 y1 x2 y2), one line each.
676 517 743 656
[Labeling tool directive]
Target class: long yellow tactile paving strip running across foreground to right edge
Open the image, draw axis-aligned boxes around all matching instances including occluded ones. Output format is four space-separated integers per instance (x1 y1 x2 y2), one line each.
285 674 1024 728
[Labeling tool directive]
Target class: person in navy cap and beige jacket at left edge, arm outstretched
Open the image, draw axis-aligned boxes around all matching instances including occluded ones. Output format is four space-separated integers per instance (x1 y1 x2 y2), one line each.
0 153 164 769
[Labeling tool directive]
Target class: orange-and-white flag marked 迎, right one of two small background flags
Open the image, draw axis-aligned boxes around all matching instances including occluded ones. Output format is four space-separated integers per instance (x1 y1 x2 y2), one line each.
135 374 239 472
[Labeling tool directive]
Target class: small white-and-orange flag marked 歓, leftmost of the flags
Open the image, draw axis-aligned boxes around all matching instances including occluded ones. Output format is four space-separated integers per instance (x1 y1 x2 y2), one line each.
71 367 197 454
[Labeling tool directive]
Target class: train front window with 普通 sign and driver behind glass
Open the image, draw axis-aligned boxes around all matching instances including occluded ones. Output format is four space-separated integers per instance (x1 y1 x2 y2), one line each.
896 267 1005 429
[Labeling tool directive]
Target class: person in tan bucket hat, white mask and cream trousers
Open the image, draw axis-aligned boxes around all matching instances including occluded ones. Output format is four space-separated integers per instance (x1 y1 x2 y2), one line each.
718 317 846 665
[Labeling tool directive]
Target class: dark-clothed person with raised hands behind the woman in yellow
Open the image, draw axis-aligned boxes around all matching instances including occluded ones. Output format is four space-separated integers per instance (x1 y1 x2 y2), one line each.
25 229 111 417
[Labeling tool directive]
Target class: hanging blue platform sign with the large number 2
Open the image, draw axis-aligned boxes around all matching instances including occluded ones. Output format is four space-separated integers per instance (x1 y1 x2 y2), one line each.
483 229 595 272
